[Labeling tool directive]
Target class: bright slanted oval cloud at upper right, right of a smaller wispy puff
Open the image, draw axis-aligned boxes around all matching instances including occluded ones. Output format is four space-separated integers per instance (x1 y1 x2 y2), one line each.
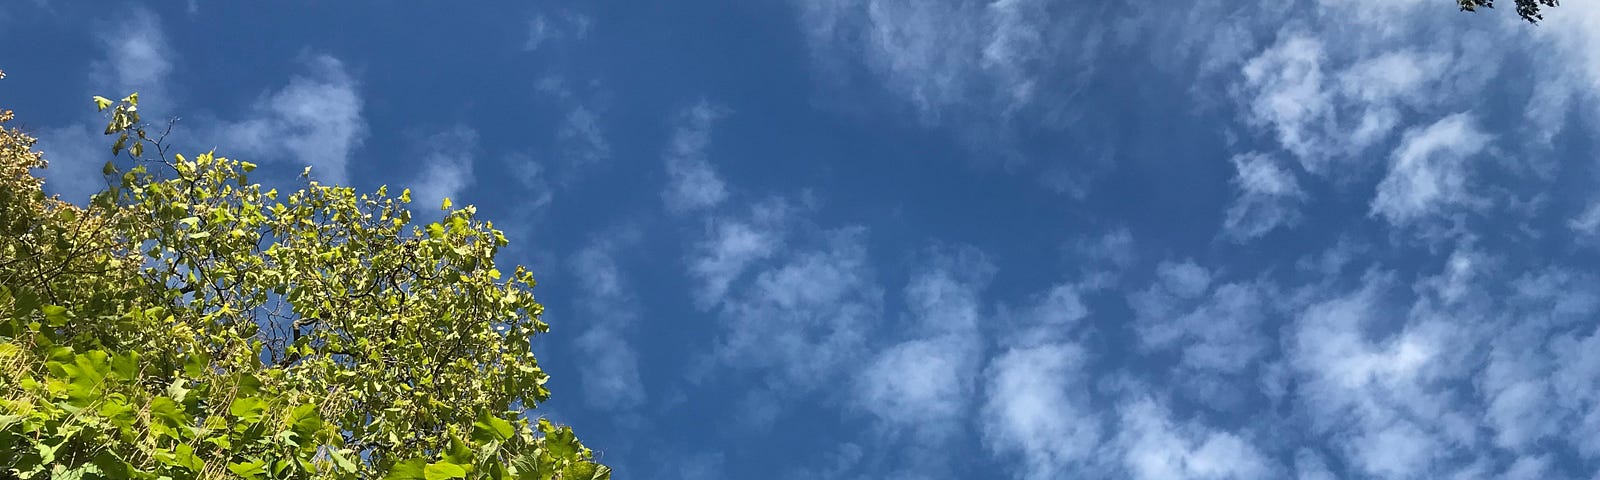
1371 114 1490 226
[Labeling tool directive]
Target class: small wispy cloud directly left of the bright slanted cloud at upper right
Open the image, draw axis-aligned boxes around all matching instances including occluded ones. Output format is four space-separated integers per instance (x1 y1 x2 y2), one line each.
1222 154 1306 242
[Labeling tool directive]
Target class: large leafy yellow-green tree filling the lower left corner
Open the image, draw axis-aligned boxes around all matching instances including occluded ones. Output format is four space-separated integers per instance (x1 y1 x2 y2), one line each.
0 78 610 480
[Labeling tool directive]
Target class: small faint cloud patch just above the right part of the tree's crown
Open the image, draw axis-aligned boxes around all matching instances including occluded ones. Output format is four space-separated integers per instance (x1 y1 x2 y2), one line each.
411 125 478 210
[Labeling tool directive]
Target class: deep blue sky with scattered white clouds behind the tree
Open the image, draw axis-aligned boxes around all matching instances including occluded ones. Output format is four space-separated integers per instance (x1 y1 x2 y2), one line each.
0 0 1600 480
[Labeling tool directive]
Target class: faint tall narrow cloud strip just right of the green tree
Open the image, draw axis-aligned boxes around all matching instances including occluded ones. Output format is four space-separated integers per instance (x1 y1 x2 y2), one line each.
571 230 645 410
